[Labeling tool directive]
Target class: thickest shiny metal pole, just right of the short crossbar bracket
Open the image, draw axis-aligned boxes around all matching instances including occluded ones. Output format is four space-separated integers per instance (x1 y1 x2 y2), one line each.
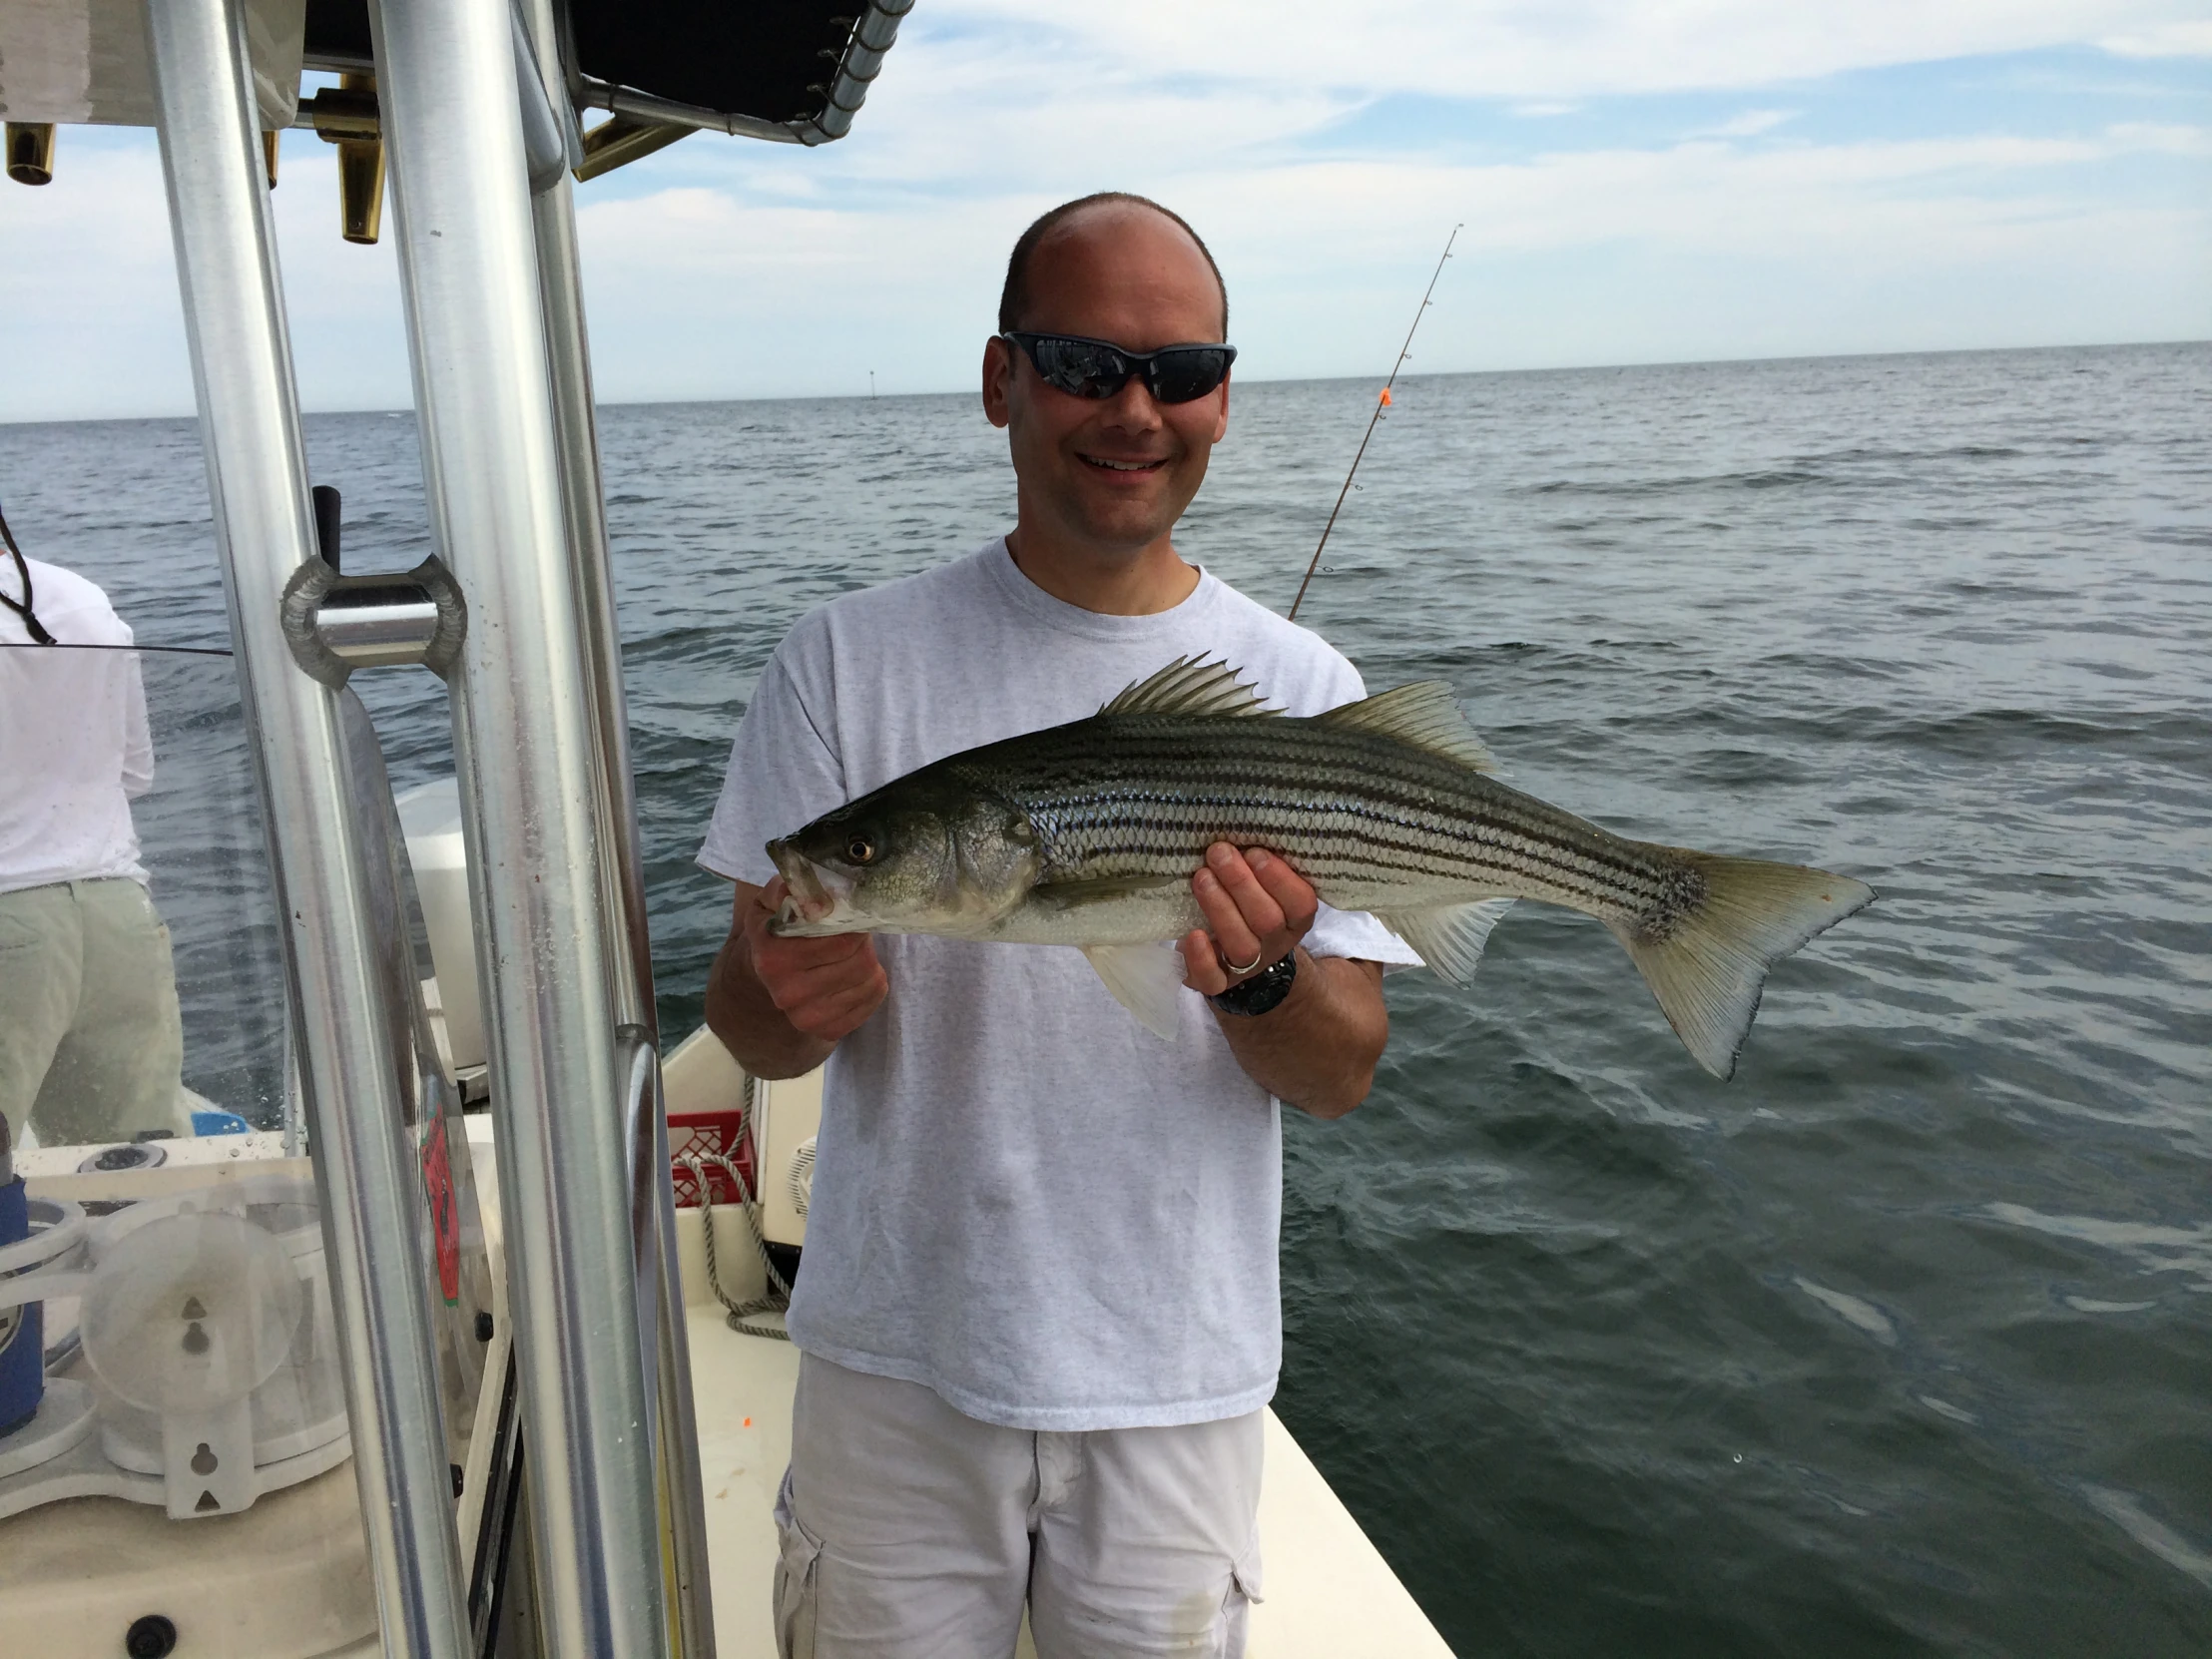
369 0 670 1659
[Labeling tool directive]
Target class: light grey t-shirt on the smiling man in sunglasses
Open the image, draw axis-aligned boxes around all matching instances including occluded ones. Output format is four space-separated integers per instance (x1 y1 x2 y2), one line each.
699 542 1417 1431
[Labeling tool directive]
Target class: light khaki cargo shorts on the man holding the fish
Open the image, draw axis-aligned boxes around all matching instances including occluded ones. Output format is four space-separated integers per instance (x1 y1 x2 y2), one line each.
775 1354 1261 1659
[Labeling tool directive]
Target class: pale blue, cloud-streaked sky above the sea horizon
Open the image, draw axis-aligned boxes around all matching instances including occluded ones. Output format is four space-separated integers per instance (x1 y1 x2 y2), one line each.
0 0 2212 420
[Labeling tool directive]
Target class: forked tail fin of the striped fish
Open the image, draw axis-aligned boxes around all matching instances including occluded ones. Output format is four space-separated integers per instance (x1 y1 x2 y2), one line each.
1606 847 1874 1079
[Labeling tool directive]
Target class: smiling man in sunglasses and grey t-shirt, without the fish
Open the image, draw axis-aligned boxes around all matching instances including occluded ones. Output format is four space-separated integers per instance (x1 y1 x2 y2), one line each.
699 193 1415 1659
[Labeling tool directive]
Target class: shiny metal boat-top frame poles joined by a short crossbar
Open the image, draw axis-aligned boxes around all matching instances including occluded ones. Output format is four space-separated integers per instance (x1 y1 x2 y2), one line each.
123 0 713 1659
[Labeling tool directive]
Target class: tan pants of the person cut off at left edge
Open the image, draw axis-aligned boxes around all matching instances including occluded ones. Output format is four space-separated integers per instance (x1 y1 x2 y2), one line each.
0 878 191 1146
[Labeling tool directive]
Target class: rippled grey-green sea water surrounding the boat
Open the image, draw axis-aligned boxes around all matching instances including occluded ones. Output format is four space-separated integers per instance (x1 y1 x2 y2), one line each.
0 345 2212 1659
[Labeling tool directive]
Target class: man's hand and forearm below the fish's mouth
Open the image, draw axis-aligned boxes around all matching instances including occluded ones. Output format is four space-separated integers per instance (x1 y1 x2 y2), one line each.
706 876 891 1077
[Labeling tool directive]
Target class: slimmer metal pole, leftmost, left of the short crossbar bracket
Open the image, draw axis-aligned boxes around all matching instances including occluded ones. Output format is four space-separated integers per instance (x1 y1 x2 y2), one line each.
146 0 469 1659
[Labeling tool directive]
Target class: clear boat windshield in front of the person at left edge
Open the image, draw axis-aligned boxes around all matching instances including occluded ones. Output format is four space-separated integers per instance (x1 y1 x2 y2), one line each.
0 646 289 1164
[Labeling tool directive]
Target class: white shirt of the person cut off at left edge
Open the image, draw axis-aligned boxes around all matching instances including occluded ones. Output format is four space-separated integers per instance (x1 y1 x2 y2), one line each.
0 551 153 893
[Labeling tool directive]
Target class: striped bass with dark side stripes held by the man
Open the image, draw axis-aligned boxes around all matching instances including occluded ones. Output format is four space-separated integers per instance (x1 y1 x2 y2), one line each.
768 657 1874 1077
